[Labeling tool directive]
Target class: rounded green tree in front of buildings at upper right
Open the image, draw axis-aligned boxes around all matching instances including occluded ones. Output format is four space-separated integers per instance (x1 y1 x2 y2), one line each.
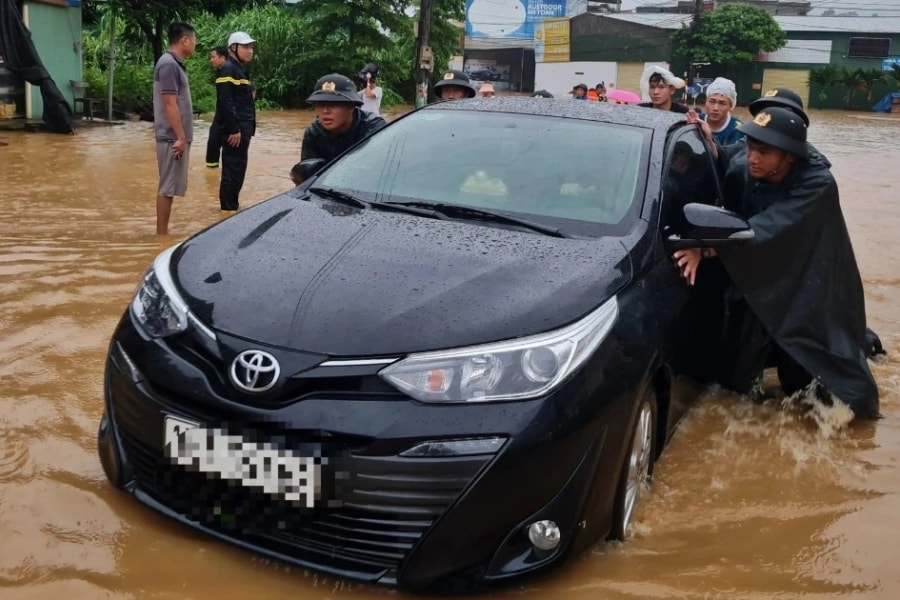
672 3 785 65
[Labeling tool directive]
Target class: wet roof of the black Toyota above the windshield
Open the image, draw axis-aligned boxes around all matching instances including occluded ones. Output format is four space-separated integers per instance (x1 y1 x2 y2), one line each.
420 96 685 139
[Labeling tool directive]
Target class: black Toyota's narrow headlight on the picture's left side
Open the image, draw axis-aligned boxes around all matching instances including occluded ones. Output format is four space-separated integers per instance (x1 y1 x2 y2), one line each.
131 246 189 338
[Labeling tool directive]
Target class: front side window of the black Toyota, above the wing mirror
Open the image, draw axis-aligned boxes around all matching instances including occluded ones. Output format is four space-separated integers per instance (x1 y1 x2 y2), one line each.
660 130 722 232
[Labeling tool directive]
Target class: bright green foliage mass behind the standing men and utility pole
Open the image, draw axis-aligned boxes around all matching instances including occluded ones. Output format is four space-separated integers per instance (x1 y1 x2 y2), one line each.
84 0 465 111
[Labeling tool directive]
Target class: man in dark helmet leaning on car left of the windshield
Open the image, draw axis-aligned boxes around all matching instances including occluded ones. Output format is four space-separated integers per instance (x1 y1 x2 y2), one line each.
291 73 387 185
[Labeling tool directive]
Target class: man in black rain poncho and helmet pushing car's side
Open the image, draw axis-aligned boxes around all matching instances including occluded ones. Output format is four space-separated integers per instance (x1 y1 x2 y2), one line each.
675 106 878 418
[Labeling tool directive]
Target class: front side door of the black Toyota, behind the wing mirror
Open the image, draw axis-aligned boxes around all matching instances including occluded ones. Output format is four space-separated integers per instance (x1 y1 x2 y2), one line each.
659 128 727 426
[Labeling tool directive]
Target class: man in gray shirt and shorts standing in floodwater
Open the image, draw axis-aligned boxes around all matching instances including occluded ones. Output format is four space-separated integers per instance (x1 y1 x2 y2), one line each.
153 23 197 235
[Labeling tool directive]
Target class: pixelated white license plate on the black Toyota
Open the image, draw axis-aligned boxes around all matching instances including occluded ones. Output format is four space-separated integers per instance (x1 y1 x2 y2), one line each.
165 416 321 508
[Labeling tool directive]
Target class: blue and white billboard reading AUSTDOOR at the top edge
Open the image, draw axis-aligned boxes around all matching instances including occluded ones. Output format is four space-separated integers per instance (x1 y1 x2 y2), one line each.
466 0 566 44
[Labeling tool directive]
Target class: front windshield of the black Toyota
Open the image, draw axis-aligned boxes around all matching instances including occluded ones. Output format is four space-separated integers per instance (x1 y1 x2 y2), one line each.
315 110 650 235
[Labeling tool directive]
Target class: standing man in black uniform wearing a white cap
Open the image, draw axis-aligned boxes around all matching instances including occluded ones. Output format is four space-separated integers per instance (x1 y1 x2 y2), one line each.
216 31 256 211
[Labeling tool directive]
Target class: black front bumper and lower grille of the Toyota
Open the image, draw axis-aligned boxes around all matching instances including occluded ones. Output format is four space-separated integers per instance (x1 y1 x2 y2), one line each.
99 314 619 588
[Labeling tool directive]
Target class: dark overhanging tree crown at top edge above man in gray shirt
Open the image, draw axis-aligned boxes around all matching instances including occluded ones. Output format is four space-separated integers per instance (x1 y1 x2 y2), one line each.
83 0 272 61
